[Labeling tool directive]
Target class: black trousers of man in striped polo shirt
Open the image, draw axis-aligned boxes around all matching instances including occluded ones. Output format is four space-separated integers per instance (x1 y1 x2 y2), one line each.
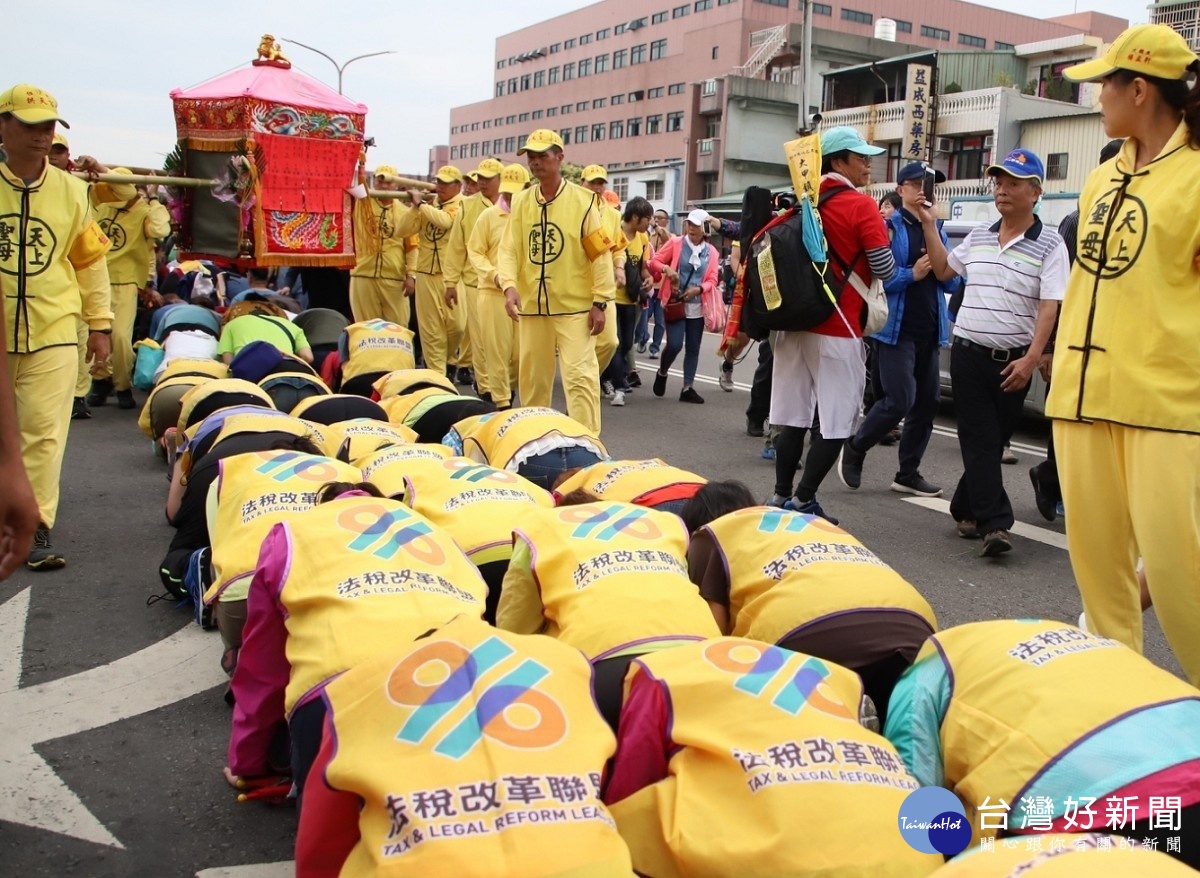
950 339 1030 534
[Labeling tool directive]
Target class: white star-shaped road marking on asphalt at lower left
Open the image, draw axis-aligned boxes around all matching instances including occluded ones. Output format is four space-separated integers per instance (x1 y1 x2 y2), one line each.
0 589 226 848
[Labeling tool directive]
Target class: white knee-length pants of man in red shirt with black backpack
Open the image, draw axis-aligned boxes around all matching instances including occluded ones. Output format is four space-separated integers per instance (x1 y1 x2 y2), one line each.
770 332 866 439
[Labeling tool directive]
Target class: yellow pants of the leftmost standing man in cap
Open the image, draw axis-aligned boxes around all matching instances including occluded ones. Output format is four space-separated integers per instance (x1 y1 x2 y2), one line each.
8 344 78 528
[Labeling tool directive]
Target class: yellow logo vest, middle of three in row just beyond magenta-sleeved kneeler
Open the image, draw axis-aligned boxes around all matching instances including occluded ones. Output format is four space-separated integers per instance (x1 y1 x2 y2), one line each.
404 457 554 565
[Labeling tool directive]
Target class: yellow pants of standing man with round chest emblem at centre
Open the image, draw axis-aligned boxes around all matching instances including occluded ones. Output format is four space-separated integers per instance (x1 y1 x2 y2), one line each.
517 313 600 433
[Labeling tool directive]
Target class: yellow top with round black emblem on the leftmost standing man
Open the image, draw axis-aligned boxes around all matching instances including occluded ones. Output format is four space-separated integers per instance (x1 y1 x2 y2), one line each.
0 163 109 354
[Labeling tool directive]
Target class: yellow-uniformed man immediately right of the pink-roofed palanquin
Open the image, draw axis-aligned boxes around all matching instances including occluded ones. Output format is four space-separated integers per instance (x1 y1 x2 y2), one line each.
350 164 416 326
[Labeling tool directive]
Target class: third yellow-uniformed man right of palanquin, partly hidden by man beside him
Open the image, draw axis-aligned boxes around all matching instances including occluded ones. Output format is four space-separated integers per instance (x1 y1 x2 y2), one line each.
442 158 504 399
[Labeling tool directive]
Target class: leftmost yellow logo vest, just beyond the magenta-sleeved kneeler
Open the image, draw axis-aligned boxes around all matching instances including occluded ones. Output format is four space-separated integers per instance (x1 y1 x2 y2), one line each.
204 453 362 603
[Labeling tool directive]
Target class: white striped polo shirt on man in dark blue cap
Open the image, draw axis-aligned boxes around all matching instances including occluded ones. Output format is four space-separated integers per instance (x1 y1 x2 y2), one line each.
947 217 1070 349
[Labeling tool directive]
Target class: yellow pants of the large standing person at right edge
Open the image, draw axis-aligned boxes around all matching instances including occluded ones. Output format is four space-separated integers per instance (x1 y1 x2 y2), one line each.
1054 421 1200 685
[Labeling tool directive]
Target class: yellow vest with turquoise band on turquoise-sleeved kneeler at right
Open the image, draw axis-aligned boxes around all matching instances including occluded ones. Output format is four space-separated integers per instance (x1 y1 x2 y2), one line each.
931 619 1200 841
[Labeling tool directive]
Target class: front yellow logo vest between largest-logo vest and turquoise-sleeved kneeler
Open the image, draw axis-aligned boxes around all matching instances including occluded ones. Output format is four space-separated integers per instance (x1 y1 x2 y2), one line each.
611 637 942 878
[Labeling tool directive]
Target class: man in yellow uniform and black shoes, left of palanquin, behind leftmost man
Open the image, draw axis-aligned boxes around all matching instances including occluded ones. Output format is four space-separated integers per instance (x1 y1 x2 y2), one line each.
80 166 170 409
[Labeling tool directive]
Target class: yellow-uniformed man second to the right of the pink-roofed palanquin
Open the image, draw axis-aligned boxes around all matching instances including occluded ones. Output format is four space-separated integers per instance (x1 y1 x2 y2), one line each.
400 164 467 377
